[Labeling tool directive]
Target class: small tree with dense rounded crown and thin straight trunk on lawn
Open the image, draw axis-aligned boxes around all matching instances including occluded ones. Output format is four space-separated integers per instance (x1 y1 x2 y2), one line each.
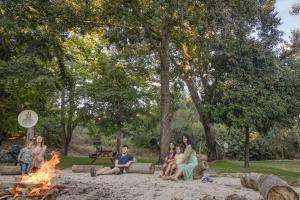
215 40 299 167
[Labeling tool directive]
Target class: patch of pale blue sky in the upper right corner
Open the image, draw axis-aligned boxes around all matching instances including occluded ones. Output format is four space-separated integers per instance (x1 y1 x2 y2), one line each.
276 0 300 40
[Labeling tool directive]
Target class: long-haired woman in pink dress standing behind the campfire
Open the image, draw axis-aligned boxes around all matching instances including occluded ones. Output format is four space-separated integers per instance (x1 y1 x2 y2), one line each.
28 136 47 173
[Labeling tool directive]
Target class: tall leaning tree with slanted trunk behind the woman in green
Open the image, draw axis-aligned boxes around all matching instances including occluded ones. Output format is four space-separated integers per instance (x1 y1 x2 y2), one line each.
163 0 280 160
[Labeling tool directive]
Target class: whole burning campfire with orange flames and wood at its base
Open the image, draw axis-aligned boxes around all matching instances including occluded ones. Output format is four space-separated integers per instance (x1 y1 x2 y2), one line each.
4 152 59 197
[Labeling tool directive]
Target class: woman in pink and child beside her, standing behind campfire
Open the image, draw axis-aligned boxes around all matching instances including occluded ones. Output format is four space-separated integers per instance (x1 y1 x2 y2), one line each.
18 136 47 174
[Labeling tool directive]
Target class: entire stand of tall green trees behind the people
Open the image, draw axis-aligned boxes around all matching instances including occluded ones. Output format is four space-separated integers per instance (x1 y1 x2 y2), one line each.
0 0 300 166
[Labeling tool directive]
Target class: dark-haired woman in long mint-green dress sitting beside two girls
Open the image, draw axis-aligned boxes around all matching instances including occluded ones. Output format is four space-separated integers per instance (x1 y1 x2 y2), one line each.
169 135 198 181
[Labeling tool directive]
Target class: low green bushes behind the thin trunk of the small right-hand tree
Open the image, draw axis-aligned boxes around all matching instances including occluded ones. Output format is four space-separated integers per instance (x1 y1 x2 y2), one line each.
217 127 297 160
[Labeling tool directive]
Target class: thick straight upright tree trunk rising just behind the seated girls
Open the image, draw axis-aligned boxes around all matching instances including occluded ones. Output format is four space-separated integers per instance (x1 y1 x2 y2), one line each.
159 25 171 164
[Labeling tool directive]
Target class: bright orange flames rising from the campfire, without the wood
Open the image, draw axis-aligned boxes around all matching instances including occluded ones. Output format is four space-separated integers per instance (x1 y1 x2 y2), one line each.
16 152 60 195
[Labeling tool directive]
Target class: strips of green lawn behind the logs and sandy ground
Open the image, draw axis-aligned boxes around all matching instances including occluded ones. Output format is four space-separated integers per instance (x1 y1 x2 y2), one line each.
59 157 300 185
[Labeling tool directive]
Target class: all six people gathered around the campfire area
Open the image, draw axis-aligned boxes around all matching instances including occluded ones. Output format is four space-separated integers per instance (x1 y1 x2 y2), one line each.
18 135 198 181
